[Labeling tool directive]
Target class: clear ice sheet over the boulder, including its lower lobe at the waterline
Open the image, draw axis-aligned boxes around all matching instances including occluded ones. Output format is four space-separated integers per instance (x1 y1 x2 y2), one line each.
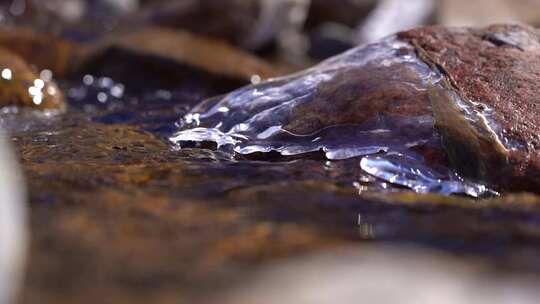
170 37 489 197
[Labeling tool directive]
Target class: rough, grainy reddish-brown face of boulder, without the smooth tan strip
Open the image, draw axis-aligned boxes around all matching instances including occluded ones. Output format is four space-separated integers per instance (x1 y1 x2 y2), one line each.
399 25 540 192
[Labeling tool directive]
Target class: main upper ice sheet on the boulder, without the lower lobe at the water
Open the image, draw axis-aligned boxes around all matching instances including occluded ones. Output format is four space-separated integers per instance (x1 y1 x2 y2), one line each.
171 38 439 158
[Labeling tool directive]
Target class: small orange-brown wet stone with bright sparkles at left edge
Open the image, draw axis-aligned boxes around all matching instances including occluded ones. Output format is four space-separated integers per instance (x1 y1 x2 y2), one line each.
0 48 66 110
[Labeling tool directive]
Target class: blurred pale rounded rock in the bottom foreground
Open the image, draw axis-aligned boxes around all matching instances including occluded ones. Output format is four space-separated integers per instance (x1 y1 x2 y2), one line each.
213 246 540 304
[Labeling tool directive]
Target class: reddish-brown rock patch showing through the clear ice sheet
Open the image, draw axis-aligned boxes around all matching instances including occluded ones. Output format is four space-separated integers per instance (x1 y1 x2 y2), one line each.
284 52 430 134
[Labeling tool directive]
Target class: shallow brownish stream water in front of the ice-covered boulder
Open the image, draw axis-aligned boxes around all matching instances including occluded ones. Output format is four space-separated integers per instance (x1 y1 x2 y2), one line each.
13 120 540 303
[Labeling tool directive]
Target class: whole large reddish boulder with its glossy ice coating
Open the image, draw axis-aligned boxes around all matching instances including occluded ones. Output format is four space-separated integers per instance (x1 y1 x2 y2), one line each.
171 25 540 193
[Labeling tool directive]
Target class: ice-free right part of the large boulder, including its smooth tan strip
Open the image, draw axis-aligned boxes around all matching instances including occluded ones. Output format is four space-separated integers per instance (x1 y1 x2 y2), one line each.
399 25 540 192
